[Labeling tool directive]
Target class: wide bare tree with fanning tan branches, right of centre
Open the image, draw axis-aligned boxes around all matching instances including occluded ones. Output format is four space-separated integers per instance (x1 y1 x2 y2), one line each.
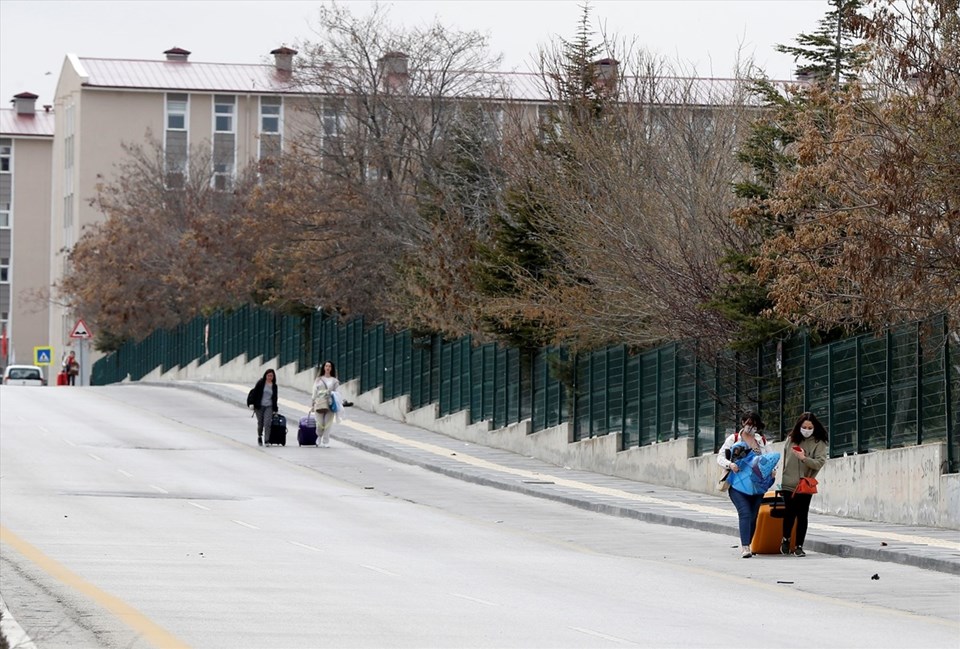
478 24 753 354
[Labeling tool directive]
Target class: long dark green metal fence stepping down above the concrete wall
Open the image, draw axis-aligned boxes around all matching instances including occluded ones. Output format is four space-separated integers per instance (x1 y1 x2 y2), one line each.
92 307 960 471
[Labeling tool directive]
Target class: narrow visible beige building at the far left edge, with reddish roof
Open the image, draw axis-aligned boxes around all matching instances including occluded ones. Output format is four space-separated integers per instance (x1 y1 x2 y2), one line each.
0 92 54 367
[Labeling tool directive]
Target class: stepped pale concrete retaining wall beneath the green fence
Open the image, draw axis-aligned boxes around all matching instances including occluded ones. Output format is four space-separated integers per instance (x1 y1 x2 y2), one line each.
144 356 960 530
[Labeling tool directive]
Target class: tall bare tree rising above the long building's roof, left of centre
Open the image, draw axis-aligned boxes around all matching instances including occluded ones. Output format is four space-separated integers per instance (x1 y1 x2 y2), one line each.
255 4 499 316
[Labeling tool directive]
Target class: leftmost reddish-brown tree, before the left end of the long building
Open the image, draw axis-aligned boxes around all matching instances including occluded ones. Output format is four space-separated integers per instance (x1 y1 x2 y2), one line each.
55 137 255 339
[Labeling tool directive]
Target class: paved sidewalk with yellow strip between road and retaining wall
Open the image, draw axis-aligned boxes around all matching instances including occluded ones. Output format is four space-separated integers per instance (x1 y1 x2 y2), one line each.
165 381 960 575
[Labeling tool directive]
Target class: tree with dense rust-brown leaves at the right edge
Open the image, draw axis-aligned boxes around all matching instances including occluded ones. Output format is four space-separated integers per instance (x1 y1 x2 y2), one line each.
756 0 960 330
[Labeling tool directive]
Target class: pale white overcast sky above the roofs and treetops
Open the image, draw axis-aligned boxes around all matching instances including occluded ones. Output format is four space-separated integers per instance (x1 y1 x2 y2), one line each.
0 0 829 105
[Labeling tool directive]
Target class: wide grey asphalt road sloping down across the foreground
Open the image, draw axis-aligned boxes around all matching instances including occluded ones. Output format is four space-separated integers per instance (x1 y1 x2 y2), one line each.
0 386 960 649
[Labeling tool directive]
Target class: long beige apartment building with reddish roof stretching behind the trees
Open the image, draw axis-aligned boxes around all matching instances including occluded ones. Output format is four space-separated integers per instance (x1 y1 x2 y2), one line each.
44 47 752 374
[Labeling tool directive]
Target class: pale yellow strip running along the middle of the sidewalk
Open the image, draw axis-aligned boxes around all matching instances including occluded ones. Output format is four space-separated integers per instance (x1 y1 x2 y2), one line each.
219 383 960 551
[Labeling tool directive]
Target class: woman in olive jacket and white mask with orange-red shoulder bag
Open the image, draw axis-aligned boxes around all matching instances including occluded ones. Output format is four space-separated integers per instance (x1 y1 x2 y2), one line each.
780 412 827 557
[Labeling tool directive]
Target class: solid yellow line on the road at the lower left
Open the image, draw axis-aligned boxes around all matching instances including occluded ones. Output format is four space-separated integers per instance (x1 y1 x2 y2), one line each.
0 525 189 649
